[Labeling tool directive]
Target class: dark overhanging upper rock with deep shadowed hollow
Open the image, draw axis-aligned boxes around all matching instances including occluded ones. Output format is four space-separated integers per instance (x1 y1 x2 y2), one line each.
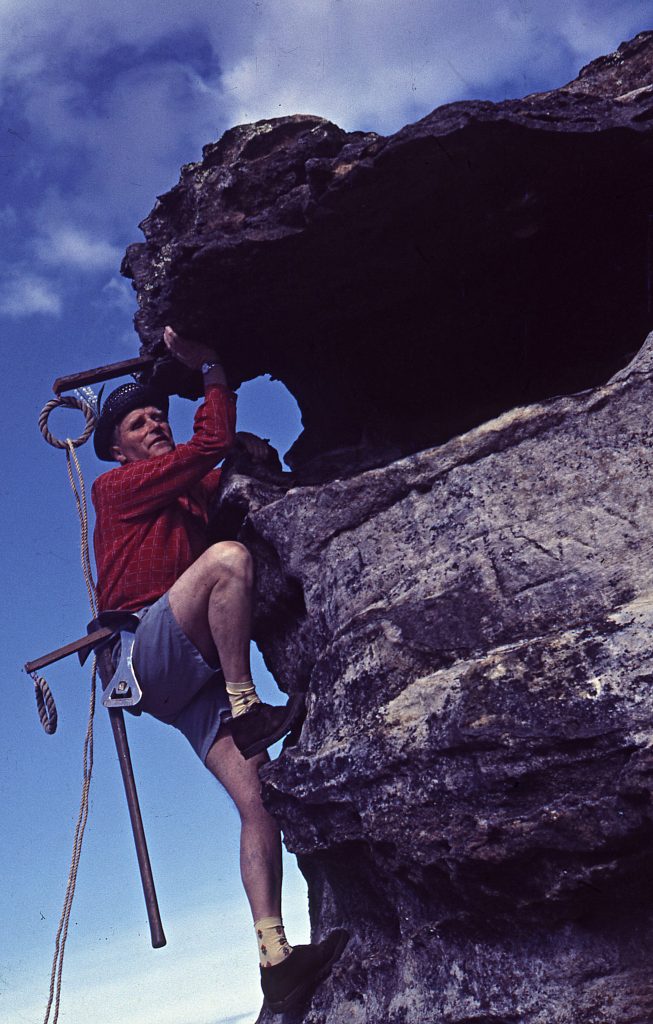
124 33 653 480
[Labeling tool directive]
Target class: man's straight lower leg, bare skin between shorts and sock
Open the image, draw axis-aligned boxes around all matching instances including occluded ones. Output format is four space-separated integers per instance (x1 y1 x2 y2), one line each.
206 730 281 922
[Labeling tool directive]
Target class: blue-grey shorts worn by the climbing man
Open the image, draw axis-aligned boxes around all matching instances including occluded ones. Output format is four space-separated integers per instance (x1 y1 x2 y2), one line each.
133 594 231 761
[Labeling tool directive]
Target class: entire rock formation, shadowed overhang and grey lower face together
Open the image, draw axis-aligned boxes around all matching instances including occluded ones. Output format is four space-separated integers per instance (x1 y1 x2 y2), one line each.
118 33 653 1024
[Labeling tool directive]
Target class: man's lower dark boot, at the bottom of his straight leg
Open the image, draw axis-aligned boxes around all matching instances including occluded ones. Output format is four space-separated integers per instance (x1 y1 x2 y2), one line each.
260 928 349 1014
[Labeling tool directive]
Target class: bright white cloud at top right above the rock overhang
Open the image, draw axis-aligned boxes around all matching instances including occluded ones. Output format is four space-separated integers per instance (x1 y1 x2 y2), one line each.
215 0 641 132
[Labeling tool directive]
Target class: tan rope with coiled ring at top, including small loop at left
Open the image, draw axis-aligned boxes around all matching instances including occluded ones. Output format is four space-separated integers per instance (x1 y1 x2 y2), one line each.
31 395 97 1024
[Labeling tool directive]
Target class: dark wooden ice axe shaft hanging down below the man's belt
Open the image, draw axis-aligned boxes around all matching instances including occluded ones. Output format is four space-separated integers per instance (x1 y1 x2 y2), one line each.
97 648 166 949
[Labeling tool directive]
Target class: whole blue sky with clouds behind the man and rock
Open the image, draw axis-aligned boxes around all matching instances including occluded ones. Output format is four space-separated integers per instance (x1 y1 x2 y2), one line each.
0 0 653 1024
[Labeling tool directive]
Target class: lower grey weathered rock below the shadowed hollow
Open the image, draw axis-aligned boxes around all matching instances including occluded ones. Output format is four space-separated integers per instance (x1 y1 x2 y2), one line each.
214 335 653 1024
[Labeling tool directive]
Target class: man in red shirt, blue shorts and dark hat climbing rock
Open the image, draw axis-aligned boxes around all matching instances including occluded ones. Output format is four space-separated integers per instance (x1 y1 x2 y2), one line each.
92 327 347 1013
